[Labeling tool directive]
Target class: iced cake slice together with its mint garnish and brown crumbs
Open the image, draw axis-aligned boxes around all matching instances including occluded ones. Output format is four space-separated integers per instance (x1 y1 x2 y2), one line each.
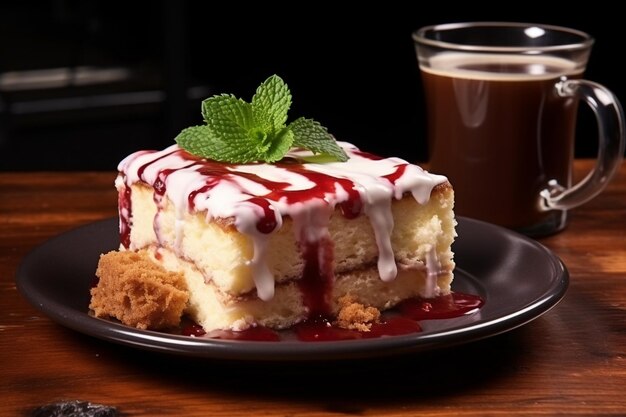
90 75 456 332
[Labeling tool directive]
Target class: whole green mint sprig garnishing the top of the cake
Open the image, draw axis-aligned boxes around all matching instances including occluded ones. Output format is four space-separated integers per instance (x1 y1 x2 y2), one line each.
175 75 348 164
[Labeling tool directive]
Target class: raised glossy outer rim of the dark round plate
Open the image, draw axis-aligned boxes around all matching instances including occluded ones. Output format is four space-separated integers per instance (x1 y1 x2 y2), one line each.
15 216 569 361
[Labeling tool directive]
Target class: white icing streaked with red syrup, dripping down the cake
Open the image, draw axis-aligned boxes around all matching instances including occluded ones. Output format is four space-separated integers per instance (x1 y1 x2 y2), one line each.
116 142 446 300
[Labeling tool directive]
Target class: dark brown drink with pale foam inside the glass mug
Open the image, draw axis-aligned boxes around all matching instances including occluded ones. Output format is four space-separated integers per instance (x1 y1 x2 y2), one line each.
421 54 581 232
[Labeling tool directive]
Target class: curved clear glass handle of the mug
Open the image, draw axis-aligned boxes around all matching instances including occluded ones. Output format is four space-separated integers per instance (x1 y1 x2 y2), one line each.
540 79 625 211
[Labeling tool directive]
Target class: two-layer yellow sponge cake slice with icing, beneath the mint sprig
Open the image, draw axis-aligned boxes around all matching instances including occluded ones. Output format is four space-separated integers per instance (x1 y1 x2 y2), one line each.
92 142 456 331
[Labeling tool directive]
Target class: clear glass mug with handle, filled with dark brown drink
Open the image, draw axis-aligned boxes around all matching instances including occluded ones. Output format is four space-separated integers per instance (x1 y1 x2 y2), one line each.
413 22 624 236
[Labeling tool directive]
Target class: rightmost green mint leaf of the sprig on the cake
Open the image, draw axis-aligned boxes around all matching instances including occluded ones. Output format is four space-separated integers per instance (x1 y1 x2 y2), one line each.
289 117 348 162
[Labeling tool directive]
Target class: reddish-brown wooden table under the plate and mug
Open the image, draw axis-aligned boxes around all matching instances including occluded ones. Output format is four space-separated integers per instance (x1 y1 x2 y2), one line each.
0 161 626 417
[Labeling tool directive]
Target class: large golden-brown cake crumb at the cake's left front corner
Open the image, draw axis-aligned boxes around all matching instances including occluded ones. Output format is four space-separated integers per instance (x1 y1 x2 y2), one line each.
89 251 189 330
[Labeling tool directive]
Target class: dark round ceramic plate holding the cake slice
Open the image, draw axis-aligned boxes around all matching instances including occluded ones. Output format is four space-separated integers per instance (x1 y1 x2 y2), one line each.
17 217 569 360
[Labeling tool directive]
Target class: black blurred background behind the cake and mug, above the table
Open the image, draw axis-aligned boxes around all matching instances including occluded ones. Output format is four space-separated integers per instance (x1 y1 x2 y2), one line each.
0 0 626 170
